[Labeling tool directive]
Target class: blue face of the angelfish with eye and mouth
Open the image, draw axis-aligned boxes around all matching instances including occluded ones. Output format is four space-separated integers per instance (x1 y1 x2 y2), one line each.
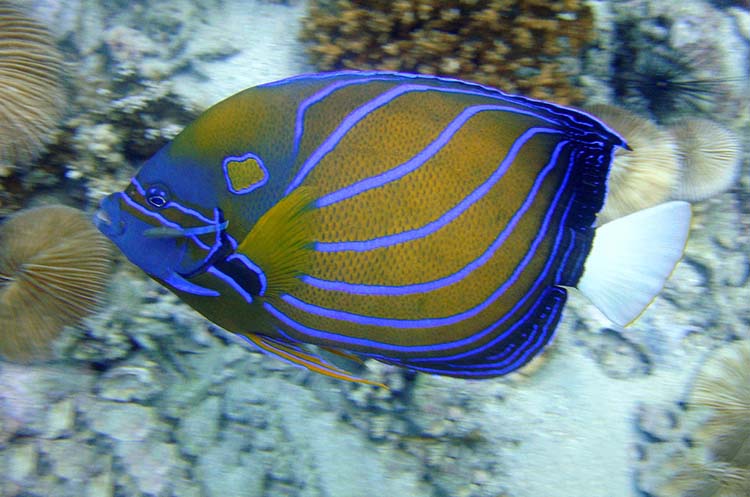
94 146 245 296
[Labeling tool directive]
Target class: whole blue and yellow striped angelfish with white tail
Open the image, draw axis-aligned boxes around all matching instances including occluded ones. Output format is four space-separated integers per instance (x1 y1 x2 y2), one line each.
96 72 690 382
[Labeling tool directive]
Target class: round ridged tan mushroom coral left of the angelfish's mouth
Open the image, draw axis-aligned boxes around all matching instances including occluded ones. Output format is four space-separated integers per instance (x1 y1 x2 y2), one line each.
0 205 111 361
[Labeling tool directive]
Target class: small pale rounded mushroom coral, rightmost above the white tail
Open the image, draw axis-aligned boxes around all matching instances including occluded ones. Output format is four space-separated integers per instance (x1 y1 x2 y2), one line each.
670 118 741 200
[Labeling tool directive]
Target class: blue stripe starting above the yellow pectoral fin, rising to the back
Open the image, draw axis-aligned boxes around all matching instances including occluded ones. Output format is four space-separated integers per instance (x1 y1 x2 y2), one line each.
284 84 575 195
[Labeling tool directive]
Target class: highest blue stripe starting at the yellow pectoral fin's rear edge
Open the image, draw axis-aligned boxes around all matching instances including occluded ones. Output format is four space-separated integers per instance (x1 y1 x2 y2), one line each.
315 105 560 207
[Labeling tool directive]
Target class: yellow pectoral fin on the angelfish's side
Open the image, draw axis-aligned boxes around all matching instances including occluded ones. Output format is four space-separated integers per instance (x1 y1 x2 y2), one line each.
237 188 312 296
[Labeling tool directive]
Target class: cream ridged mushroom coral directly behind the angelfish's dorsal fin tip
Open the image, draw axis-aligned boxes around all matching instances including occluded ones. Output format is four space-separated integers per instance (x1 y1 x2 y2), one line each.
586 105 679 224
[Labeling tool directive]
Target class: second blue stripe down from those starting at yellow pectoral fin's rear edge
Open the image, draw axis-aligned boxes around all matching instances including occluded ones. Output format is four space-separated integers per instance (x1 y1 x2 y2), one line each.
314 128 561 252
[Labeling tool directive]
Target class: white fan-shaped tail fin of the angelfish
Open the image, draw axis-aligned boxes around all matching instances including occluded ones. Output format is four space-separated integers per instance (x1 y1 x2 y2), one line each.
577 202 691 326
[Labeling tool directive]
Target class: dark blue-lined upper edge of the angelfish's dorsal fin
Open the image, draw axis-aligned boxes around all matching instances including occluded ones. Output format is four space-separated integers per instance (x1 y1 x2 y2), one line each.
259 70 627 147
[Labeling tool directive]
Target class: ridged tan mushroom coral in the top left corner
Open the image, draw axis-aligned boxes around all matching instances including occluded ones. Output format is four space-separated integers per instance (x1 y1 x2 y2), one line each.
0 0 65 163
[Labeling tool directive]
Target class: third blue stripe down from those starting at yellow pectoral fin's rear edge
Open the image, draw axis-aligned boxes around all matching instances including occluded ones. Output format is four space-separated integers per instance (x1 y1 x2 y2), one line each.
300 142 569 295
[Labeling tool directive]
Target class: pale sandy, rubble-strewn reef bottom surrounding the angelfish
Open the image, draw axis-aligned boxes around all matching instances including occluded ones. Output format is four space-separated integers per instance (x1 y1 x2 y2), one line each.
0 0 750 497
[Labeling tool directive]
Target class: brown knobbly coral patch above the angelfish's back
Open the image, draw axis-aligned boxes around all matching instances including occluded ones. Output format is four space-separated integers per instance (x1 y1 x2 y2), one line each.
302 0 593 103
